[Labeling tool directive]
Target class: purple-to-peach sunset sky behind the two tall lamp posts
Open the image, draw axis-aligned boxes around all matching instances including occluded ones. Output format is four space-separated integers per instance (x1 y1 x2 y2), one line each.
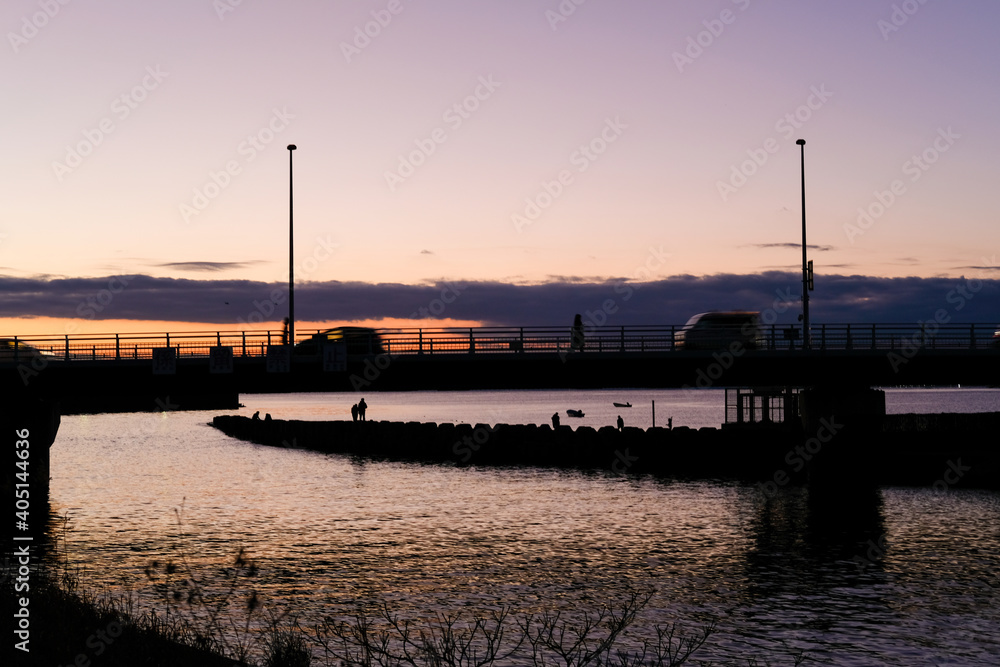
0 0 1000 333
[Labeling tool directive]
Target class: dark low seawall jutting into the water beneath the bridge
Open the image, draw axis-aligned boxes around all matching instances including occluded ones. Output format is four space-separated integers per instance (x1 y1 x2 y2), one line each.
212 414 1000 487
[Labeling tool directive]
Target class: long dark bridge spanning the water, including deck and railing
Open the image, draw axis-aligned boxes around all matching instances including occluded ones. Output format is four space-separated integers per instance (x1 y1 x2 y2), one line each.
0 322 1000 413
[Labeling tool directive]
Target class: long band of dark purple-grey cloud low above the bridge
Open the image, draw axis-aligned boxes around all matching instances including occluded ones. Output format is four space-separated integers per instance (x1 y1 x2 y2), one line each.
0 271 1000 326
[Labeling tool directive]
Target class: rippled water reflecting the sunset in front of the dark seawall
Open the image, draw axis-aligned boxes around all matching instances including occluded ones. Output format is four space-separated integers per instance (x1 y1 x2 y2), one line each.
37 394 1000 665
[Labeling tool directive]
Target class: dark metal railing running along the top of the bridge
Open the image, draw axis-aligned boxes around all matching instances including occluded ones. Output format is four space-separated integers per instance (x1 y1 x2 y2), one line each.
0 322 1000 362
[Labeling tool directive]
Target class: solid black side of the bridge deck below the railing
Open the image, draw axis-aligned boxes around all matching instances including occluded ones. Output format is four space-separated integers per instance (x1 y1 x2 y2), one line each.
0 349 1000 414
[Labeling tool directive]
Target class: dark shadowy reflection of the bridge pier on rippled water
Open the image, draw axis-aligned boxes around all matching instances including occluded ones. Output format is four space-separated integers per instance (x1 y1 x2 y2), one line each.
740 486 889 664
